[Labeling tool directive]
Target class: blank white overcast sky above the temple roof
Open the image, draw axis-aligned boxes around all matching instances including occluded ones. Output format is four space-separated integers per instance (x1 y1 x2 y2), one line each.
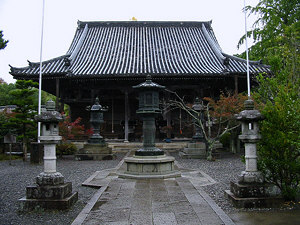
0 0 259 83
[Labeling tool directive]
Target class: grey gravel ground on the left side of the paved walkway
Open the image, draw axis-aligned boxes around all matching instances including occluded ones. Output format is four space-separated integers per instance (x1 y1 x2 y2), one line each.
0 154 124 225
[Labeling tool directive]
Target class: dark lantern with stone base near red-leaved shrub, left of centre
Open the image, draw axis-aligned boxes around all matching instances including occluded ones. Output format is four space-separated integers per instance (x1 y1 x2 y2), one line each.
75 97 115 160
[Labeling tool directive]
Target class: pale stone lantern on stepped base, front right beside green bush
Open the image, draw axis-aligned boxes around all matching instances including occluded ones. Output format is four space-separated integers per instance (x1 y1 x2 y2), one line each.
225 99 283 208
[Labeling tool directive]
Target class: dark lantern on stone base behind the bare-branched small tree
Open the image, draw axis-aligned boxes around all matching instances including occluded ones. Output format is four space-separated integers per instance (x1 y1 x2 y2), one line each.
179 98 206 159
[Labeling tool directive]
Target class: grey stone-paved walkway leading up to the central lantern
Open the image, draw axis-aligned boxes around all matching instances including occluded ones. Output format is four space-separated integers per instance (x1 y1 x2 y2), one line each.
72 156 234 225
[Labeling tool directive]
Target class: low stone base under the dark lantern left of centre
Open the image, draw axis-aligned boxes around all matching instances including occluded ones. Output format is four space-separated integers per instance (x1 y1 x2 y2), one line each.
75 143 116 160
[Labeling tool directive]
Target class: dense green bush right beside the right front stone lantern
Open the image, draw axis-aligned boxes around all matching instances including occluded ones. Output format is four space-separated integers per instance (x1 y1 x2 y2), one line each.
258 79 300 200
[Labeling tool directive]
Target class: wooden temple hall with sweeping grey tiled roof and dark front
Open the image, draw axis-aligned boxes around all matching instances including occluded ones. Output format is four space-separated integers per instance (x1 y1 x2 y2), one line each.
10 21 270 140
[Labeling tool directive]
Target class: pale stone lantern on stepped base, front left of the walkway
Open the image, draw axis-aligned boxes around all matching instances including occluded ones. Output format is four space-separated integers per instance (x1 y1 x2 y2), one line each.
19 101 78 211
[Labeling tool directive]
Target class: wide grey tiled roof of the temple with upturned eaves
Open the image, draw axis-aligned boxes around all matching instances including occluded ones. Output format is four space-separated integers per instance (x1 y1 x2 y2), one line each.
11 21 270 78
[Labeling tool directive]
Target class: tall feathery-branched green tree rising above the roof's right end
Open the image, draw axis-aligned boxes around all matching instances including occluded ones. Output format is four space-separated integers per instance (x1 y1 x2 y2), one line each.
238 0 300 76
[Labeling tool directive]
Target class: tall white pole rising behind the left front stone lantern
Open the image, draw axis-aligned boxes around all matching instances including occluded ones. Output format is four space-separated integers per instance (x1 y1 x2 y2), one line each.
38 0 45 142
